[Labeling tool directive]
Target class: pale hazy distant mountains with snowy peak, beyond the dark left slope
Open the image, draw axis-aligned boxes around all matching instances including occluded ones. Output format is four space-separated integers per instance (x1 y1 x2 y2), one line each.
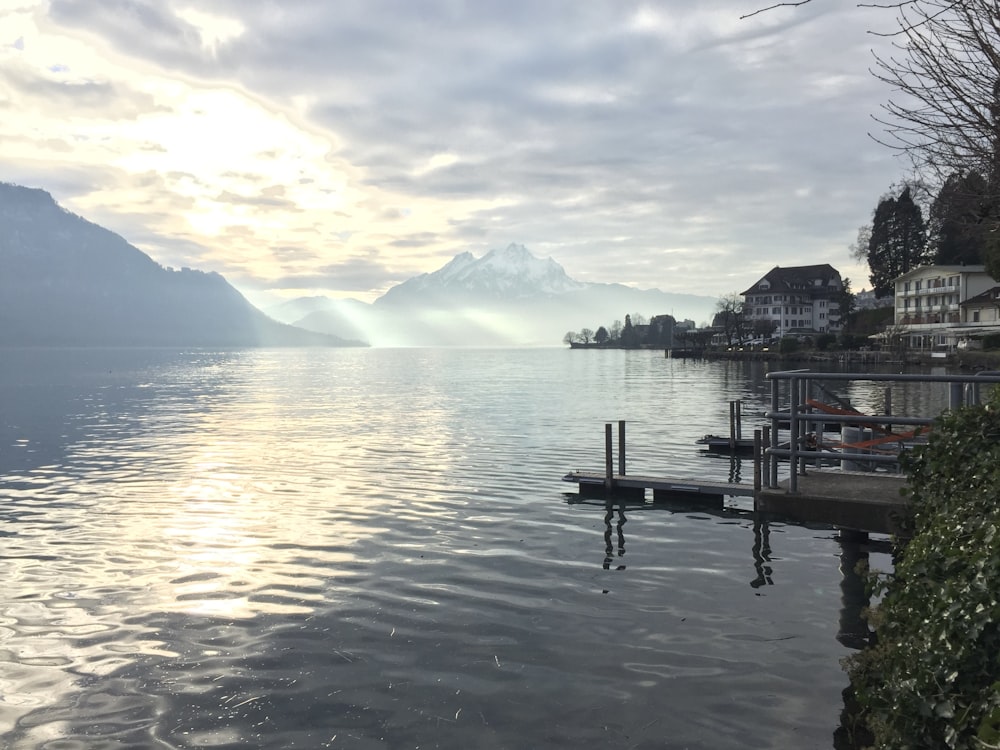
269 244 716 346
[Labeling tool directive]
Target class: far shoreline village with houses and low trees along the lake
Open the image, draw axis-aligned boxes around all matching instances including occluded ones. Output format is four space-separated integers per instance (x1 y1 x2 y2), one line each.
563 263 1000 354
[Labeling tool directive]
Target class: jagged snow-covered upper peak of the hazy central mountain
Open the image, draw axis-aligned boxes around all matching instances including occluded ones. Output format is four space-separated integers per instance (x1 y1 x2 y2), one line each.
375 243 587 305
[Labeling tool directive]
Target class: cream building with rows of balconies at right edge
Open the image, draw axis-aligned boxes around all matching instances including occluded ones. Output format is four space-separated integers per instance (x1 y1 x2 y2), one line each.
894 266 997 349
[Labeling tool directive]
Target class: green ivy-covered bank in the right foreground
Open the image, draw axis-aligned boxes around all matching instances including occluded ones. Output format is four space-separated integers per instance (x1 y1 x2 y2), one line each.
847 394 1000 750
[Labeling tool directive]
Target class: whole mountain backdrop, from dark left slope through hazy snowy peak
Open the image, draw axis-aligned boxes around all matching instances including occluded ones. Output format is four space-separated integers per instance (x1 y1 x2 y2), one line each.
0 183 715 347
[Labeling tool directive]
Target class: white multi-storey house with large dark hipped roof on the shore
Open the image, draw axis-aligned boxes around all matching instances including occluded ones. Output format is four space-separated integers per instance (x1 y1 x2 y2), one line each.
743 263 844 336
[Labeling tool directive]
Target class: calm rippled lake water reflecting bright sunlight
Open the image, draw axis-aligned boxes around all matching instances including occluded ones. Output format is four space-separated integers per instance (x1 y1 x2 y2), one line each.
0 349 905 750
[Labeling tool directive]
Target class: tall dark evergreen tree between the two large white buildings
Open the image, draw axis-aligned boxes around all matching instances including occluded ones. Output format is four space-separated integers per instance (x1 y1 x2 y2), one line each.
868 186 930 297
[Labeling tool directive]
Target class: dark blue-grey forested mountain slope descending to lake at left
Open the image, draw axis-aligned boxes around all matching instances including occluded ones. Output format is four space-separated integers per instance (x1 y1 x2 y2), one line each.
0 183 365 347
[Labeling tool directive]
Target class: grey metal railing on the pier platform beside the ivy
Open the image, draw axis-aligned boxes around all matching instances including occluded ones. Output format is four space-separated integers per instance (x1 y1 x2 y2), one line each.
755 370 1000 493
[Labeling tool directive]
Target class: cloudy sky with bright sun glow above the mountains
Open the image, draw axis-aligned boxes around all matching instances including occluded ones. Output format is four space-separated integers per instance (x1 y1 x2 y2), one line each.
0 0 907 303
